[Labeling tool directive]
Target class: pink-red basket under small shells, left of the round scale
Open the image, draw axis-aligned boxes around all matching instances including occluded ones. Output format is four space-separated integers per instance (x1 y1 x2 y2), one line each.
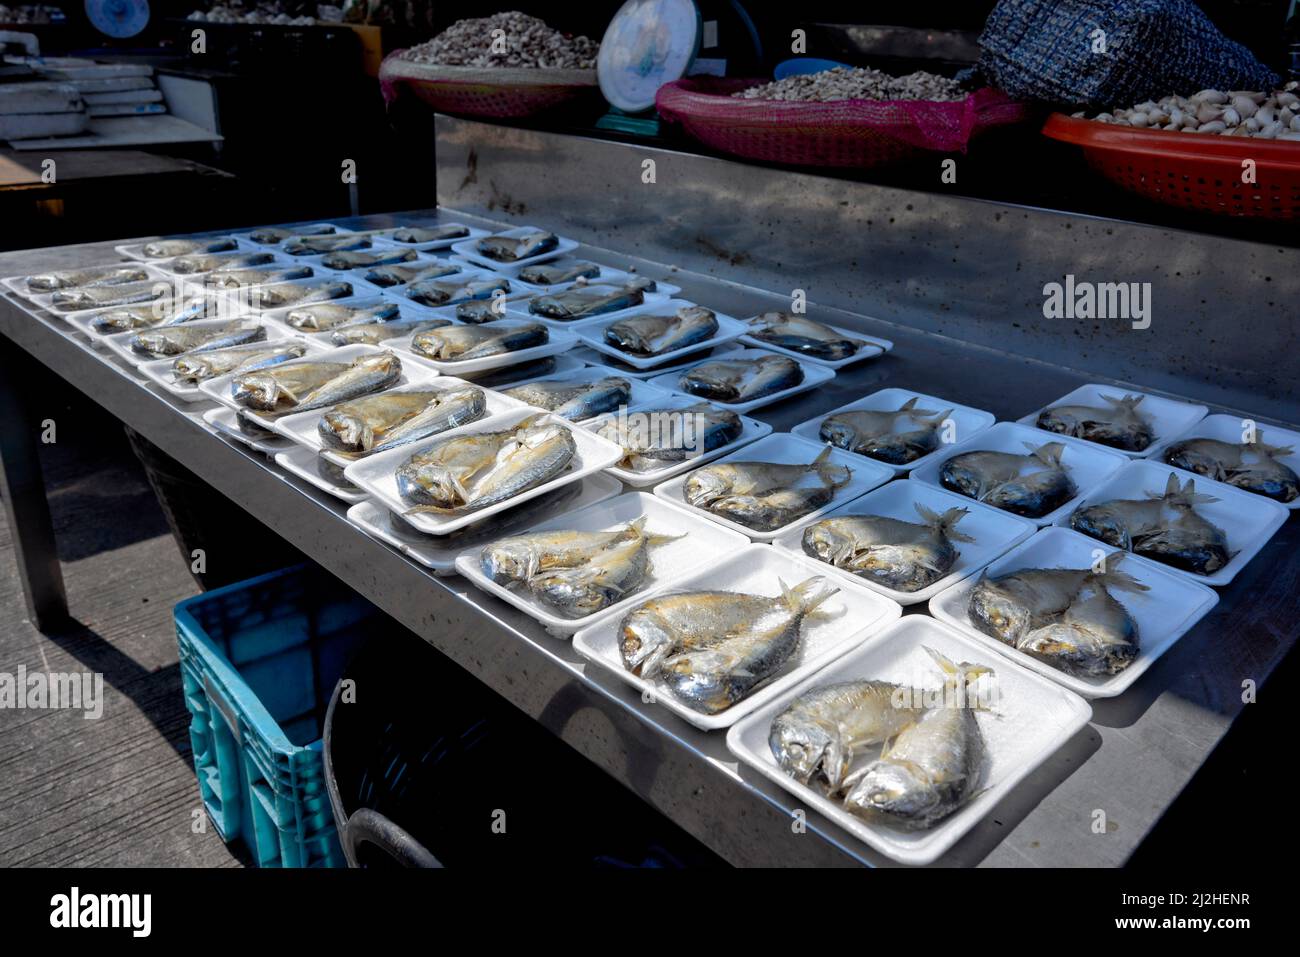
380 51 598 120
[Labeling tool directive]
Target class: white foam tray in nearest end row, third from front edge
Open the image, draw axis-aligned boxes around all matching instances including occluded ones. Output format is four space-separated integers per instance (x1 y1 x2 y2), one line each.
1056 459 1290 586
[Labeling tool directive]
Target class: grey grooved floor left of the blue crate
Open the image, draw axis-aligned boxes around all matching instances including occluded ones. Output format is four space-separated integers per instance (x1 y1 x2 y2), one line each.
0 395 242 866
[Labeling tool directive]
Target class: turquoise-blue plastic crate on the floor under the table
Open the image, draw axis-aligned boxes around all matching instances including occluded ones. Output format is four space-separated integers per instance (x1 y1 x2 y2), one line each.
174 566 380 867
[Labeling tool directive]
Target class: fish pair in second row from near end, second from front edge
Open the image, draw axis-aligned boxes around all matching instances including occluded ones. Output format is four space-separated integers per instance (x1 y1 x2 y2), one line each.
803 502 975 593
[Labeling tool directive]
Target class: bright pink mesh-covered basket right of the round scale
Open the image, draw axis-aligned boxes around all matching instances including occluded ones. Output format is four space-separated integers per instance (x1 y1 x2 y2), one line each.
655 77 1027 168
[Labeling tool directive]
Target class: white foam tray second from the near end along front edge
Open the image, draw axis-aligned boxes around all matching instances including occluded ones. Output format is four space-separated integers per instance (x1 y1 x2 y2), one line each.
573 545 902 731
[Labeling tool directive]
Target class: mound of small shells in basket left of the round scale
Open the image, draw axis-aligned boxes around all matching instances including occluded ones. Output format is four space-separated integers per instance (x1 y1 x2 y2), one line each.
402 10 599 70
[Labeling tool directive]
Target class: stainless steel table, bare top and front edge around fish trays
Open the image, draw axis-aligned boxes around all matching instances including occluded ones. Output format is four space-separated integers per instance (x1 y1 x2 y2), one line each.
0 209 1300 866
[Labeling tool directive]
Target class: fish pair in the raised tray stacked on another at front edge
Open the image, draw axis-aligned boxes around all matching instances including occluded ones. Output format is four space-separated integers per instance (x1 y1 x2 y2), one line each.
397 413 577 514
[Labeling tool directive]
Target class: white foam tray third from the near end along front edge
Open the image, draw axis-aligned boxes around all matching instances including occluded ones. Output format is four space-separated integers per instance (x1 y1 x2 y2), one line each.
456 492 749 636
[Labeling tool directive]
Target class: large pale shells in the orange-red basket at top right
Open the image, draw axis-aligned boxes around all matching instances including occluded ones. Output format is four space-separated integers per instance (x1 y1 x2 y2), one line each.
1074 81 1300 140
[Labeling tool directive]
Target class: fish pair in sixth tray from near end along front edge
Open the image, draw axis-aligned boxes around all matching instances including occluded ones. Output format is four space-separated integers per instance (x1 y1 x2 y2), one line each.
230 352 402 412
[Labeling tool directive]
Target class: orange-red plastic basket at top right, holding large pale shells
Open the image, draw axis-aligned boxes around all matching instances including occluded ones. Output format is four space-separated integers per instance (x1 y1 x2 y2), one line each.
1043 113 1300 220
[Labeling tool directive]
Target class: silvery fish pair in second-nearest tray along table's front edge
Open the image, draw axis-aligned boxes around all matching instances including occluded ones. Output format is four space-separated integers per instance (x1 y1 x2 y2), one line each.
619 576 840 714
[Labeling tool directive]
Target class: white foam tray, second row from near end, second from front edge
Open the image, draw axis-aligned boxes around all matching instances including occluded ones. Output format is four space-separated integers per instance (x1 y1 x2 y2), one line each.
772 481 1037 605
